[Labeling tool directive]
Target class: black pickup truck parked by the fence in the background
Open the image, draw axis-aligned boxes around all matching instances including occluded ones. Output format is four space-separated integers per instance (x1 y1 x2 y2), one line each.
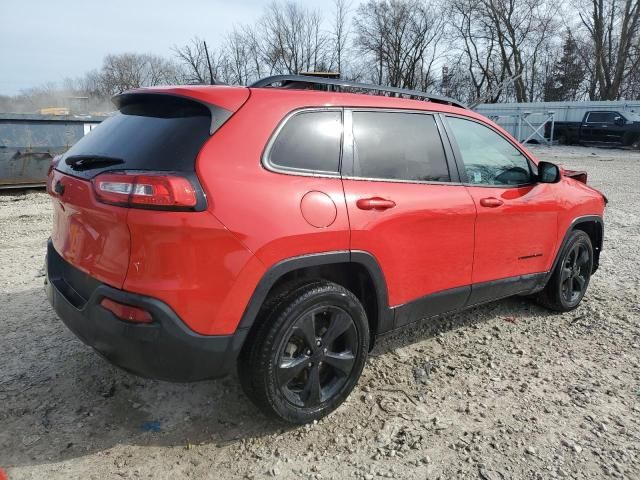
545 110 640 148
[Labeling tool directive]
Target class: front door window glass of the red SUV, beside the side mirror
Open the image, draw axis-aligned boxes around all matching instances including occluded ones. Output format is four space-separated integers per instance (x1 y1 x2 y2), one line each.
448 117 531 185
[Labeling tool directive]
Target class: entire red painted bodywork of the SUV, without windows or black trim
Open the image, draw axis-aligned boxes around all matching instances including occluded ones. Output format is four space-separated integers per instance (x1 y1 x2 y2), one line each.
47 86 604 335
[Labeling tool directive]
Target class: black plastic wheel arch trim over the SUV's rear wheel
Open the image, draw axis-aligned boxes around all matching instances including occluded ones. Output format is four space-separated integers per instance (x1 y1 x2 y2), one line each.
238 250 393 332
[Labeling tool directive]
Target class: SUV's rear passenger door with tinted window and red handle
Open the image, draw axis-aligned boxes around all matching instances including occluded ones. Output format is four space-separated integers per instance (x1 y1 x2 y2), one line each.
342 109 476 326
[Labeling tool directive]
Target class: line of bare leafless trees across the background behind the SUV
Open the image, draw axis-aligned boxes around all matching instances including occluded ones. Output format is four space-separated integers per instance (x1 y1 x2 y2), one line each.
13 0 640 108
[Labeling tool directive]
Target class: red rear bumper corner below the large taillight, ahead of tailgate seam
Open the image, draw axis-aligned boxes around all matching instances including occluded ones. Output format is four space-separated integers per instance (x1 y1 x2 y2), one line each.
124 209 265 335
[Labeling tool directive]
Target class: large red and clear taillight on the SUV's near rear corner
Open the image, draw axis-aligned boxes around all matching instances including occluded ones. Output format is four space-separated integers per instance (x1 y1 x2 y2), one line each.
93 173 198 209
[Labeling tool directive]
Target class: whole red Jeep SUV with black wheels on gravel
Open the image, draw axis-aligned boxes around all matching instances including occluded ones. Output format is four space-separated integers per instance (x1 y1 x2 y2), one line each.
47 76 606 423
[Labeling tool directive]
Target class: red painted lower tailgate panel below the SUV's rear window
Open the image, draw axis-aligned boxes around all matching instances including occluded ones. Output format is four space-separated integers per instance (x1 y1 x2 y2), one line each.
49 170 129 288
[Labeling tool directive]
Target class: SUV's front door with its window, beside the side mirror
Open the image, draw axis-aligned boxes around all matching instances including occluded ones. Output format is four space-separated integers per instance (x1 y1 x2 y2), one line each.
446 116 560 294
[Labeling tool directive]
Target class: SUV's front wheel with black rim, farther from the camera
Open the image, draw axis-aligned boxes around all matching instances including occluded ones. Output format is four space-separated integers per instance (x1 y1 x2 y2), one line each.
538 230 593 312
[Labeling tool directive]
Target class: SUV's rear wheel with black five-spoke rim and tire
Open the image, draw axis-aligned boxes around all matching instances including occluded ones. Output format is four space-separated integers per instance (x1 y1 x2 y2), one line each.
238 281 369 424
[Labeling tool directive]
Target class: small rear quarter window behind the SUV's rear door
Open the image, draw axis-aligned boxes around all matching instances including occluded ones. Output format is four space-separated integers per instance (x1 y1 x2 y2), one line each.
269 111 342 172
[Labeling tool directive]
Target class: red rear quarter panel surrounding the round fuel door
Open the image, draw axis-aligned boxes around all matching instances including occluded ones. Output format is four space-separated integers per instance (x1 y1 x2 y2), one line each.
196 89 349 270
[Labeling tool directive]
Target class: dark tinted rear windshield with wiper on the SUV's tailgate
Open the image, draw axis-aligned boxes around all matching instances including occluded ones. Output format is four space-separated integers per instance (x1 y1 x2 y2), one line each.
57 94 226 178
